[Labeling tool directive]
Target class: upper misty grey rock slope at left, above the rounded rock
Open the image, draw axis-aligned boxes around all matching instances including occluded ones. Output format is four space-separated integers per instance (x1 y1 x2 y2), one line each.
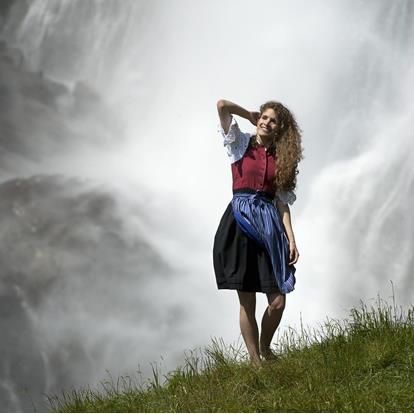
0 41 122 176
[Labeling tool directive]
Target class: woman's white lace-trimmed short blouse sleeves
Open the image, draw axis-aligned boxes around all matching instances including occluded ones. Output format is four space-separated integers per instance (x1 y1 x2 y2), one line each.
217 116 296 205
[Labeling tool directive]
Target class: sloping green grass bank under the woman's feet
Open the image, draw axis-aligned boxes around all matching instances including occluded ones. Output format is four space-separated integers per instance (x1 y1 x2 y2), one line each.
48 299 414 412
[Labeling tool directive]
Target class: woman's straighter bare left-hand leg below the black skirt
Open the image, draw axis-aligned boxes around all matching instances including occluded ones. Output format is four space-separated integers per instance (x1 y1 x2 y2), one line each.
237 291 261 366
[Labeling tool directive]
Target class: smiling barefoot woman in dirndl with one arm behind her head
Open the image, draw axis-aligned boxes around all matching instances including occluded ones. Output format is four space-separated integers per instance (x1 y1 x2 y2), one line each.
213 99 303 366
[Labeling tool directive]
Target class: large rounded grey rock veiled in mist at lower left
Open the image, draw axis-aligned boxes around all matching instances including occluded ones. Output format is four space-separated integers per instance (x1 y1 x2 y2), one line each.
0 176 172 411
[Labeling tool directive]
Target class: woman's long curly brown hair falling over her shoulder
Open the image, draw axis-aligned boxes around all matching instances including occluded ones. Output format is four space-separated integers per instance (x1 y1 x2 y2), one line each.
250 101 303 191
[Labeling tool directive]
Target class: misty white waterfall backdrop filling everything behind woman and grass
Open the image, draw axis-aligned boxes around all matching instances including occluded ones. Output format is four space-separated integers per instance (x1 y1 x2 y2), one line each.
0 0 414 411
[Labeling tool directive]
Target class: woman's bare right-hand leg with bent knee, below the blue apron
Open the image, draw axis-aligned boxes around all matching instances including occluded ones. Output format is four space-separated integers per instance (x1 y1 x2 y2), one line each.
260 293 286 359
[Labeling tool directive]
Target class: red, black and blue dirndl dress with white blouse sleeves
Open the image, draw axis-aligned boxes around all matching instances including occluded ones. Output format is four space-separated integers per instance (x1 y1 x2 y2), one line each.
213 117 296 294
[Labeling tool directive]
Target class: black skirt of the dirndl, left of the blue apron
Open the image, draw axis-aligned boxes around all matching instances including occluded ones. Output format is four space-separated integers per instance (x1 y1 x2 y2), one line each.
213 203 279 293
